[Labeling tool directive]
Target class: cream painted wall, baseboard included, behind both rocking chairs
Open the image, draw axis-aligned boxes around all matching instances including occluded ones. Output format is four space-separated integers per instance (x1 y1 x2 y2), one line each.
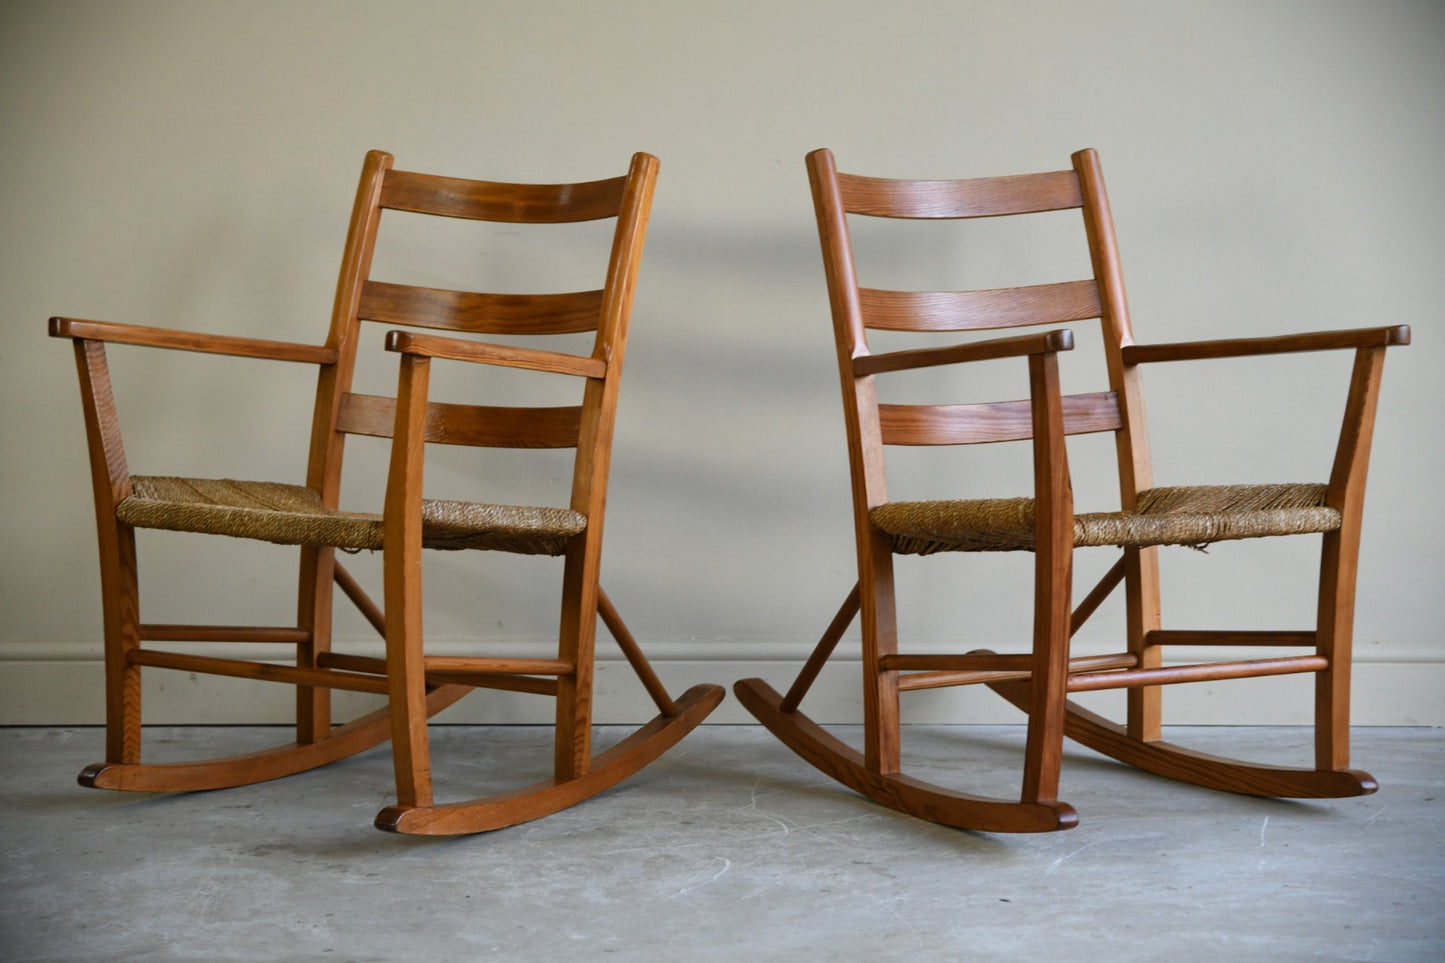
0 0 1445 724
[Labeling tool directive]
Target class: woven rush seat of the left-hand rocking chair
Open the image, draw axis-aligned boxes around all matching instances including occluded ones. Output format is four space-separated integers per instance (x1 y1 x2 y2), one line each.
116 474 587 555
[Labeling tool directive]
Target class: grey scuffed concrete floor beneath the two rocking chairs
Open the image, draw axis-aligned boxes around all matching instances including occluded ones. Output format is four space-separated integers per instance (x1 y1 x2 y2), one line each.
0 726 1445 963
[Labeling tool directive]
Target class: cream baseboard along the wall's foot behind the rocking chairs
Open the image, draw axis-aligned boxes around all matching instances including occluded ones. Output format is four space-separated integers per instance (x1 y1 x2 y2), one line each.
0 643 1445 726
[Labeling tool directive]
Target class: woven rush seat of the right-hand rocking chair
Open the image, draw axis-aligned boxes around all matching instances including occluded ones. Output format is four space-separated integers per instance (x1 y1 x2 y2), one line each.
868 484 1340 555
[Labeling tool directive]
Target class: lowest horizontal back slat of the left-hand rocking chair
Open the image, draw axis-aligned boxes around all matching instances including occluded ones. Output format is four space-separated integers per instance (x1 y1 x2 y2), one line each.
337 395 582 448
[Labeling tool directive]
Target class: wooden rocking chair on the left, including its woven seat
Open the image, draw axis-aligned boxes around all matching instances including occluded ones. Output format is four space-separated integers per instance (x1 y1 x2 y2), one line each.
51 152 723 834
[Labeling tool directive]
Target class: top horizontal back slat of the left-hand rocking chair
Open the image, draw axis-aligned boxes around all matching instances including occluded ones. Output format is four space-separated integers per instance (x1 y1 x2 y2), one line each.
381 171 627 224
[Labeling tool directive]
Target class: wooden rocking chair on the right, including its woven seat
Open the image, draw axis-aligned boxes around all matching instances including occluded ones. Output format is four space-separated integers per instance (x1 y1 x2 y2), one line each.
734 150 1410 833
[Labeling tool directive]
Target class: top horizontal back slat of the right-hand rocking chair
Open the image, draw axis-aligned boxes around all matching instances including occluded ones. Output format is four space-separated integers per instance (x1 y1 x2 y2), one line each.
838 171 1084 217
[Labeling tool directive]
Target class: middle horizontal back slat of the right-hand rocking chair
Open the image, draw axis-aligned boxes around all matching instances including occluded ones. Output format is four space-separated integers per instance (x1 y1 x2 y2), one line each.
858 281 1101 331
